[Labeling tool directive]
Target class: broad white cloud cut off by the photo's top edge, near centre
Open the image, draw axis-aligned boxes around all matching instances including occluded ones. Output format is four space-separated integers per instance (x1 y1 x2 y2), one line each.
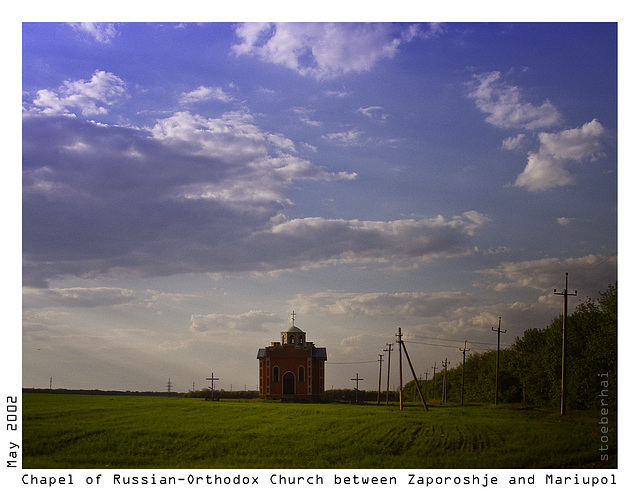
232 23 442 79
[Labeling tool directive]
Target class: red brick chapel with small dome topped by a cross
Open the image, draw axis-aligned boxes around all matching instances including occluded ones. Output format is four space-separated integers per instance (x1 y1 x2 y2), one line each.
258 312 327 401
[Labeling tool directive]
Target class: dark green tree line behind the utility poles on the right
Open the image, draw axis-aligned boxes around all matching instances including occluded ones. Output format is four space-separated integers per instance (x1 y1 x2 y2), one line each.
403 283 618 409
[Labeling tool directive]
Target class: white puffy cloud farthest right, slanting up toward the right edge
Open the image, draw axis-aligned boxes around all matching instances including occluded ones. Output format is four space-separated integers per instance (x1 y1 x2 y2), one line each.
514 119 605 191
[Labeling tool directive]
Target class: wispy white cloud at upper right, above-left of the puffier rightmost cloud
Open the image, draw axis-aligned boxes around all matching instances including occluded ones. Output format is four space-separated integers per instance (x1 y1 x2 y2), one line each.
469 72 561 130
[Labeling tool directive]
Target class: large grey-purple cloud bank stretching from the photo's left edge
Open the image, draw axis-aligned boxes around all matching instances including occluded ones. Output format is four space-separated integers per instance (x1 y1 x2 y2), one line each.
23 104 487 287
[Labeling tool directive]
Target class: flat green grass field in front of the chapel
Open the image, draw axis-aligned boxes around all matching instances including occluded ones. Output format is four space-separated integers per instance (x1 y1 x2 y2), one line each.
22 393 617 469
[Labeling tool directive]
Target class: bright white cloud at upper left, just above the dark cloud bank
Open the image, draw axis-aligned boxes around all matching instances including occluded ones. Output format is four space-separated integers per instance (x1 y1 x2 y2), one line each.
32 70 127 116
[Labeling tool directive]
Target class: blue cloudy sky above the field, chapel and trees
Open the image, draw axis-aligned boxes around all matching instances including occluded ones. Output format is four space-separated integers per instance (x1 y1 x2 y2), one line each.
21 22 618 392
